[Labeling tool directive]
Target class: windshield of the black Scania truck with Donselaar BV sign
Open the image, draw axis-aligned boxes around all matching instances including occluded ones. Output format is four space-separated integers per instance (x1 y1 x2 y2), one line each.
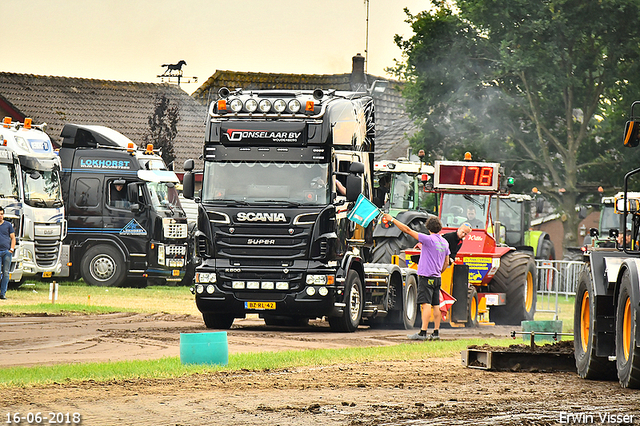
202 161 330 205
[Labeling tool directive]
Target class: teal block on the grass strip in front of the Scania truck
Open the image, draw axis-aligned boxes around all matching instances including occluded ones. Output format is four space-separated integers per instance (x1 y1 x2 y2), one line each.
180 331 229 365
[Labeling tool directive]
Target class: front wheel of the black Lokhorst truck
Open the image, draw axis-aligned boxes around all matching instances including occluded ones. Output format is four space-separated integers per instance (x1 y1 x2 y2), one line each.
80 244 127 287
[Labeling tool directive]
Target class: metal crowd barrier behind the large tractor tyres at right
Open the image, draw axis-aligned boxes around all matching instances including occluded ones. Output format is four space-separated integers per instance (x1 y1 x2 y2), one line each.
536 260 586 319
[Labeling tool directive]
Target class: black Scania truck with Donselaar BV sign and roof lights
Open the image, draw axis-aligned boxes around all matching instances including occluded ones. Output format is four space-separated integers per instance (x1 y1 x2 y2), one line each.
183 88 417 332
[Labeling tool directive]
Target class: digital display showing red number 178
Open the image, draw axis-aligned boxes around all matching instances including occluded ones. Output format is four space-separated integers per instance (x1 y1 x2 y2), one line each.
433 161 500 192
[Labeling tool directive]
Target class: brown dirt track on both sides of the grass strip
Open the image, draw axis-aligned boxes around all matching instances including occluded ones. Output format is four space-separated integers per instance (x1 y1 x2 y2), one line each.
0 314 640 426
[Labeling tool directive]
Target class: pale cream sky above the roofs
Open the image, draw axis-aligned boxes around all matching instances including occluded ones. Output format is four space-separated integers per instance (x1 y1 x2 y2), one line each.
7 0 427 93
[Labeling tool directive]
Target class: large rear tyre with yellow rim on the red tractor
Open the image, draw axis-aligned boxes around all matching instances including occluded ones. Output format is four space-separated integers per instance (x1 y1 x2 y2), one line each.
489 251 537 325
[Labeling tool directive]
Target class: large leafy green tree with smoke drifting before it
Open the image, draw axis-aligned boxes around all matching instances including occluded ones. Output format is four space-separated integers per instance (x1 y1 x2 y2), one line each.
393 0 640 250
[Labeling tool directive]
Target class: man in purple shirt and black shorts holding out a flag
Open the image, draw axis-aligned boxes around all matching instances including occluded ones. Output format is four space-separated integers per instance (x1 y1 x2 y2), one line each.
385 213 450 340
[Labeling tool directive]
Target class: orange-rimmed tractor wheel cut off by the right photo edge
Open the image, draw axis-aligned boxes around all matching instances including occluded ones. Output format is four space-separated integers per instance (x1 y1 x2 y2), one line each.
616 269 640 389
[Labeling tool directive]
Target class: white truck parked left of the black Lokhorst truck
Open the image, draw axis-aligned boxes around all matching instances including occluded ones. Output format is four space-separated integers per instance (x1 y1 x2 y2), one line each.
0 117 67 285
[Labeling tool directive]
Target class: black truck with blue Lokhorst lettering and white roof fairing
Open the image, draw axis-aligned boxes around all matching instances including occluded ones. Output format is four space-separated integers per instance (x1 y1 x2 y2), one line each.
57 124 187 286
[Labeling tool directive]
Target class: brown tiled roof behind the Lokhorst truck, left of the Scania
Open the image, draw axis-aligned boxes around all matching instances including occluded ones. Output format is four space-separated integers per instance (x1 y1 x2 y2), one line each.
0 72 206 170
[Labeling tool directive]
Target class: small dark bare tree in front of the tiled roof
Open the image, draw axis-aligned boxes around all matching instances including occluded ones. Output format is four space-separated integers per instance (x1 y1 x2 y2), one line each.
144 94 180 165
